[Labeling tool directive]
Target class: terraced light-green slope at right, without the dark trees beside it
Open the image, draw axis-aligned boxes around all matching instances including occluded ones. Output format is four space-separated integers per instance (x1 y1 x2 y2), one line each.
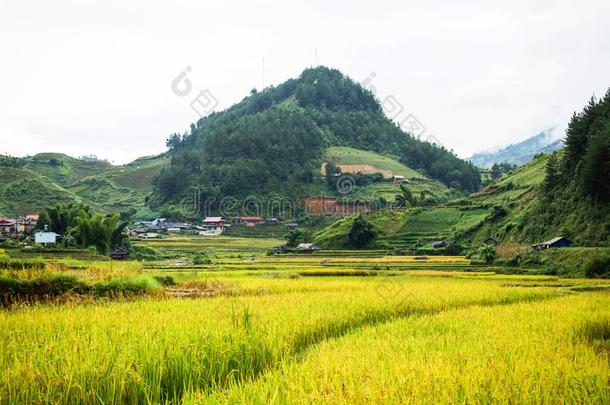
316 155 553 249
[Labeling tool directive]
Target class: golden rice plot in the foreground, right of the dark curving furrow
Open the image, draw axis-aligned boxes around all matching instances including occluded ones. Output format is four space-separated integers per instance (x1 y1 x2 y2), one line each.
203 295 610 404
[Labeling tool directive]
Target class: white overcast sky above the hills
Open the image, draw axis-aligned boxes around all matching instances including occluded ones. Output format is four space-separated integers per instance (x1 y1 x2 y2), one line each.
0 0 610 163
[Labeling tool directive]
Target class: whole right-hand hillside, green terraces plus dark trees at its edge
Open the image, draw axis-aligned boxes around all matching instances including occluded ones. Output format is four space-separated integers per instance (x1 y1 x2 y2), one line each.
315 90 610 250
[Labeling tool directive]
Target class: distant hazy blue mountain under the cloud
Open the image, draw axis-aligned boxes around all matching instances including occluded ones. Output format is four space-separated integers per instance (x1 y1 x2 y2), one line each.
467 129 562 168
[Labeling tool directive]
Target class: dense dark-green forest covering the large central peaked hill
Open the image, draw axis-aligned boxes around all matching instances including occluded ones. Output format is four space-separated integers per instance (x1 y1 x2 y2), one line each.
151 67 480 206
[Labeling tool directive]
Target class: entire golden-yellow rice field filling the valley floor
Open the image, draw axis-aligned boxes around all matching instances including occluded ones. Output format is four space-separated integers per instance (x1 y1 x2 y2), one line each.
0 234 610 404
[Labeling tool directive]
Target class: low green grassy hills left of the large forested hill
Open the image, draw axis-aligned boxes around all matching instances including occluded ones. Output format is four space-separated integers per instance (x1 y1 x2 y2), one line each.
0 153 169 216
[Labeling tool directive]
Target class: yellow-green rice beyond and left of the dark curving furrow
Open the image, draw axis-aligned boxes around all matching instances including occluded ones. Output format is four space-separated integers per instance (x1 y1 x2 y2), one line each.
0 278 557 404
